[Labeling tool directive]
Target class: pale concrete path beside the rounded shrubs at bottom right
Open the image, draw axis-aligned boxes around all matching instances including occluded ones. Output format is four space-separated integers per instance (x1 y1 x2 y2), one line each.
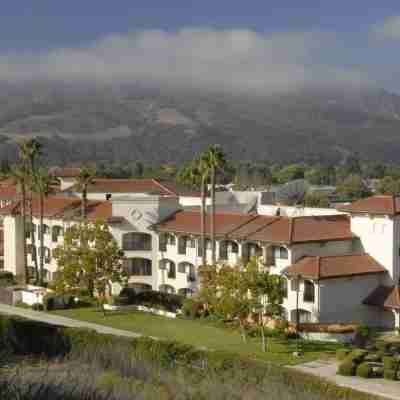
289 360 400 400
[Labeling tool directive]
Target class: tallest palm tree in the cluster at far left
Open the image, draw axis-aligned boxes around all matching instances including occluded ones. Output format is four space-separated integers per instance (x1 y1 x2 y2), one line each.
19 138 42 282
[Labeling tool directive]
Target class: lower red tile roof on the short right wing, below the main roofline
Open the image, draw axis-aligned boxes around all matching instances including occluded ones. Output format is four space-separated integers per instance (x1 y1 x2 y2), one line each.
284 254 387 280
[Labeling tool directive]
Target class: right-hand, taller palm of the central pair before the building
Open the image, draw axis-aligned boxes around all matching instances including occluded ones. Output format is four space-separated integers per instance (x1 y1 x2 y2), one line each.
204 144 226 265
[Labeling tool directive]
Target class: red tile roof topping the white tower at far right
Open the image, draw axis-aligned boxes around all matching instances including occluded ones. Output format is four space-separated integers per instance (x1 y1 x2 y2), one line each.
339 195 400 215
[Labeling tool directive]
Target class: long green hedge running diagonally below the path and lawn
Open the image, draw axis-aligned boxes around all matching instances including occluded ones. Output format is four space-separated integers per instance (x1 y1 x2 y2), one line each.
0 316 382 400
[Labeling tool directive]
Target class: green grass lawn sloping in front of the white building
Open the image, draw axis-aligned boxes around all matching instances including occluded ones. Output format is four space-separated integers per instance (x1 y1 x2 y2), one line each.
51 308 342 365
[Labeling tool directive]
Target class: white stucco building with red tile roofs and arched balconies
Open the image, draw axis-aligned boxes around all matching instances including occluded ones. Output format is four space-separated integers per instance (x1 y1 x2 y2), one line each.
0 180 400 328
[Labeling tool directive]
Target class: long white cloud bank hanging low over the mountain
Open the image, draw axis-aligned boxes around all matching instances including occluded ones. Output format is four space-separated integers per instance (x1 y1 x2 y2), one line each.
0 29 365 93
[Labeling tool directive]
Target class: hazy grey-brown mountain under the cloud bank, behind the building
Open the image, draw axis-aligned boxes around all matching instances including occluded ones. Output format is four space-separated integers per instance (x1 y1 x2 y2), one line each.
0 82 400 164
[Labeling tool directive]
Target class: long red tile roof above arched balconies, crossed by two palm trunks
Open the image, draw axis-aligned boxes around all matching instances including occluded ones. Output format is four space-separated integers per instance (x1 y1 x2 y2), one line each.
156 211 354 243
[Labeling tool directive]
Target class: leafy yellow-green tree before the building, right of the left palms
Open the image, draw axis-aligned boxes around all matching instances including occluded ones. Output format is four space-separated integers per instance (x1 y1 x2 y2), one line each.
54 221 126 296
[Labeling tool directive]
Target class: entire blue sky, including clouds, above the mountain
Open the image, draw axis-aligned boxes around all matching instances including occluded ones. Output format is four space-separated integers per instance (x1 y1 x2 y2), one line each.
0 0 400 91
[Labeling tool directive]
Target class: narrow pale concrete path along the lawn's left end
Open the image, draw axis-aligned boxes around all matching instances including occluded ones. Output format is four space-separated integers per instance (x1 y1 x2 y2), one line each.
0 304 144 339
